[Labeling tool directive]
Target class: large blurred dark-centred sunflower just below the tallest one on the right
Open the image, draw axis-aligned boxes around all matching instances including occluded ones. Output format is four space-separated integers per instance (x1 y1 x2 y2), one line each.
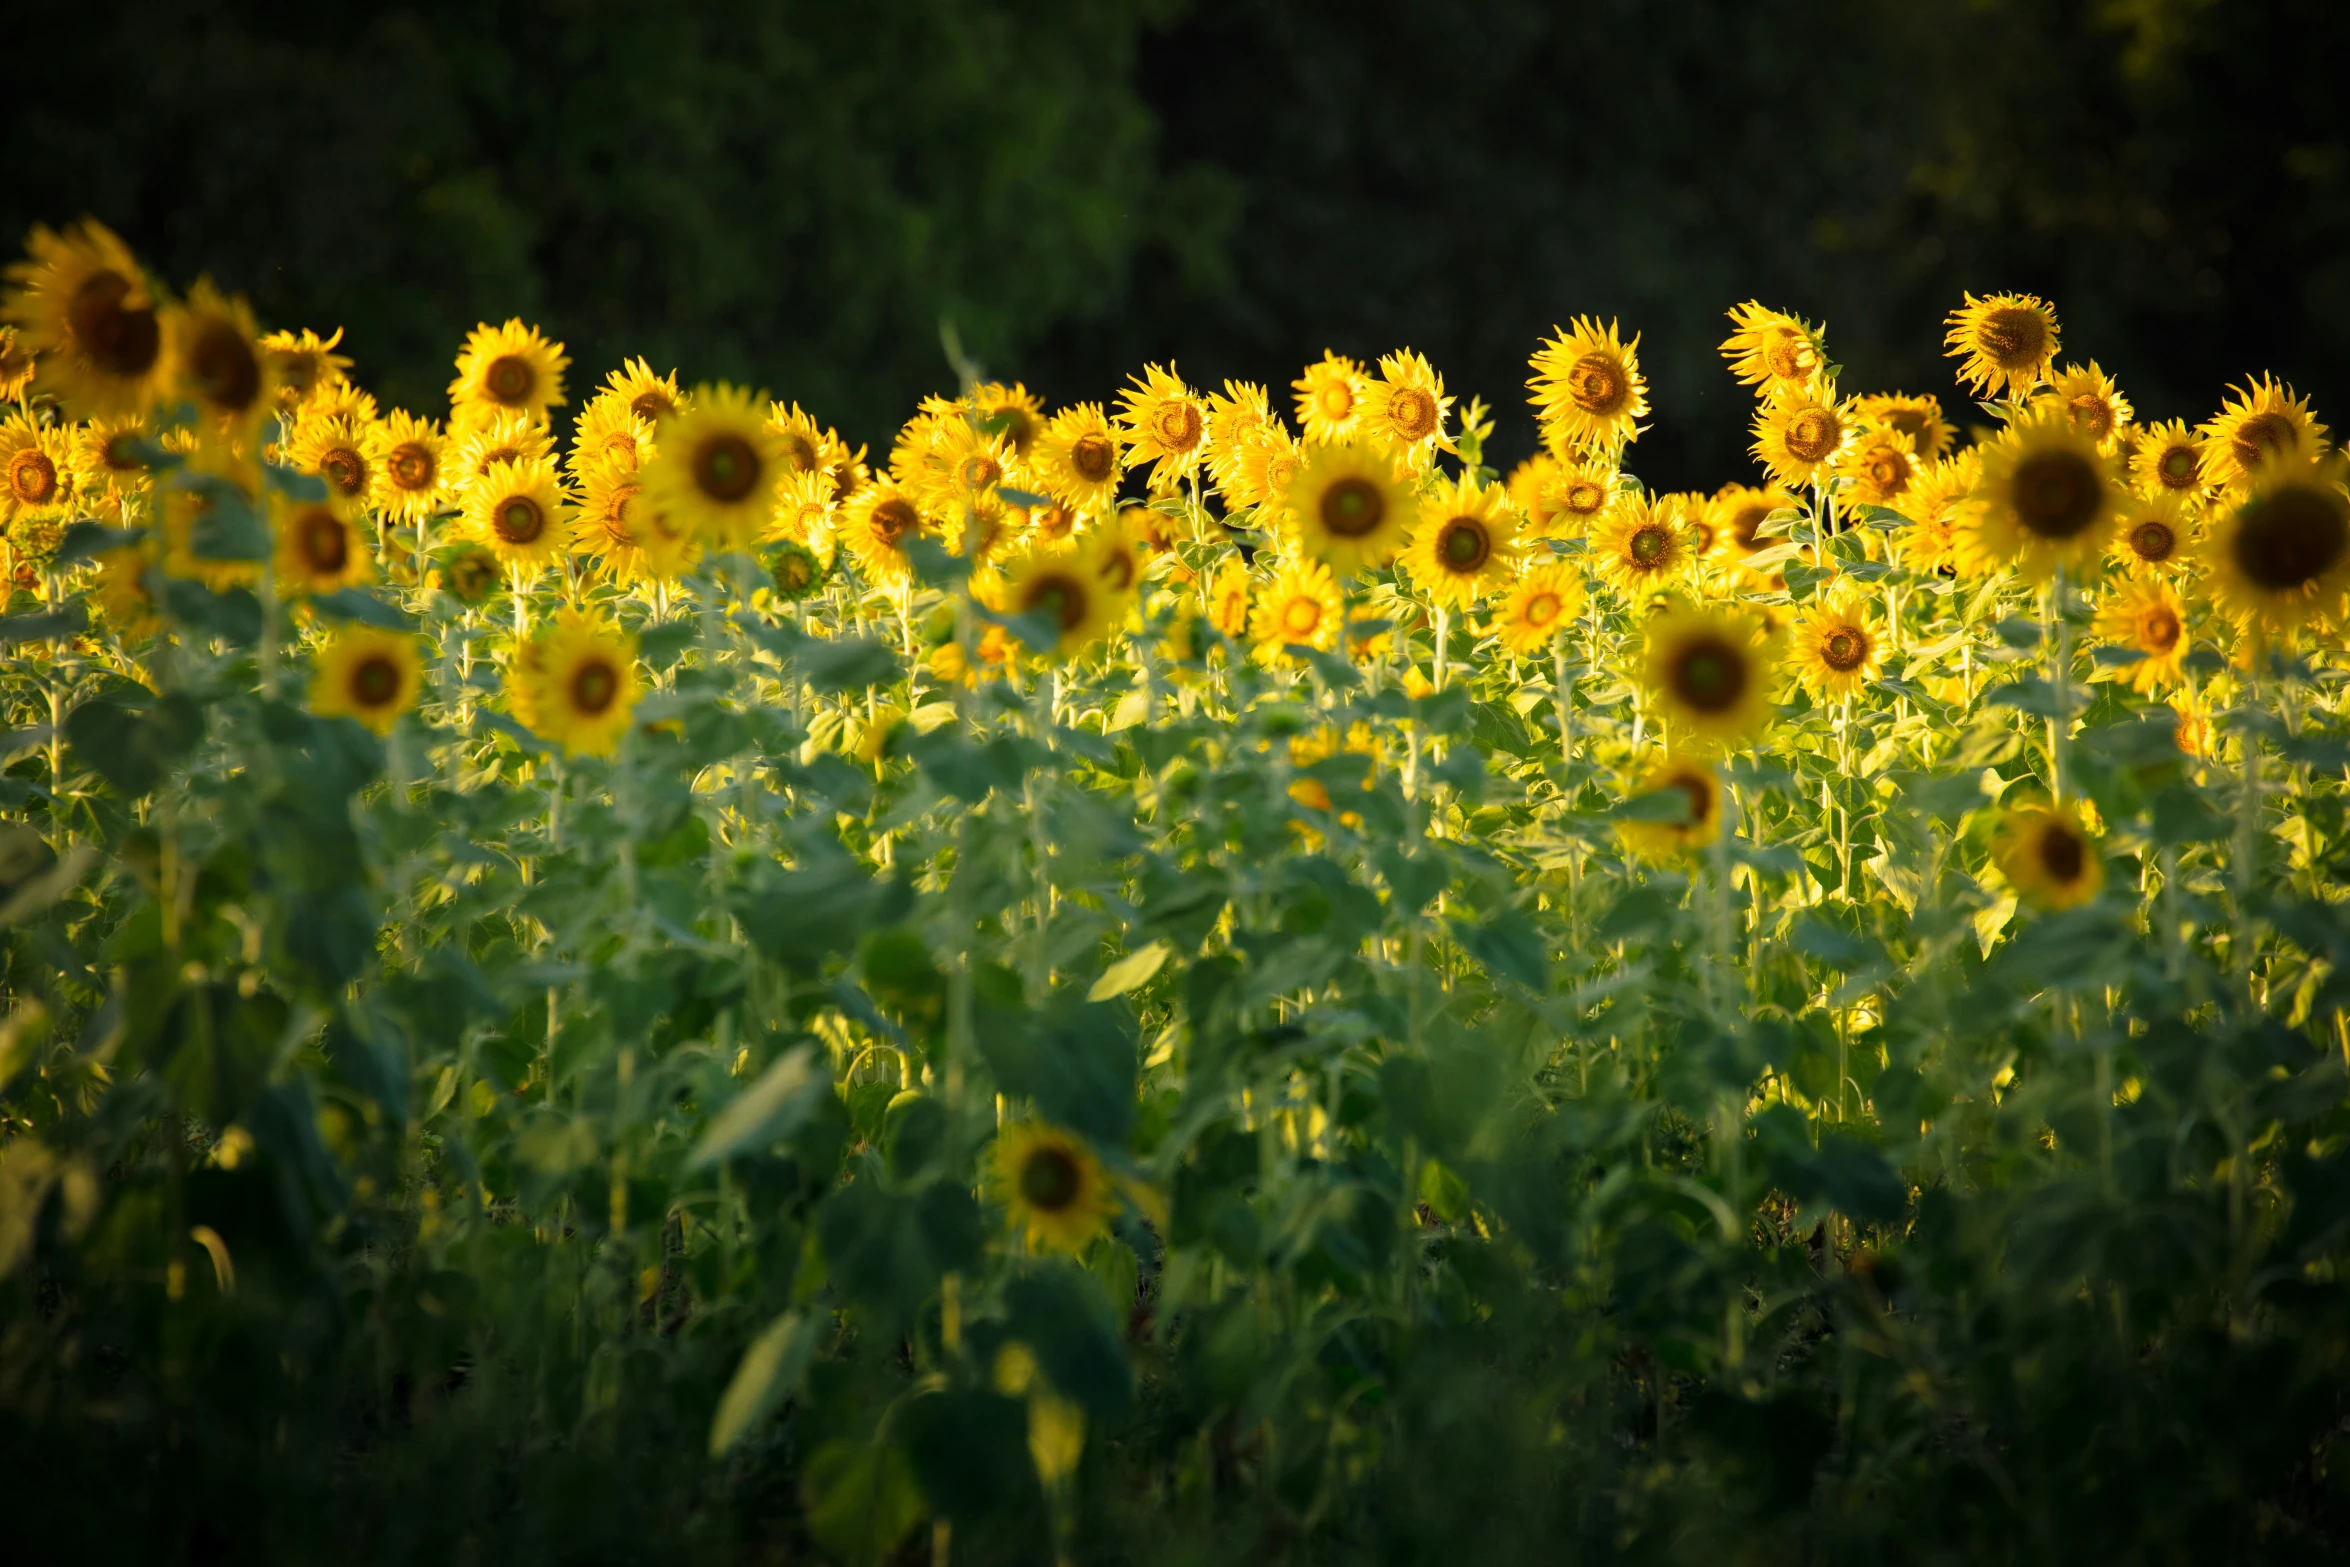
1960 409 2120 583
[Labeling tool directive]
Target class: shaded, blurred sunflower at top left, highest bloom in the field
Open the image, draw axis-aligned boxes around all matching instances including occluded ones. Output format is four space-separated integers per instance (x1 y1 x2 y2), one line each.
0 218 172 418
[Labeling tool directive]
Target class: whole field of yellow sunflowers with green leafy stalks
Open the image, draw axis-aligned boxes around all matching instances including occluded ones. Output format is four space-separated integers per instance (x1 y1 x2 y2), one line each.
0 223 2350 1567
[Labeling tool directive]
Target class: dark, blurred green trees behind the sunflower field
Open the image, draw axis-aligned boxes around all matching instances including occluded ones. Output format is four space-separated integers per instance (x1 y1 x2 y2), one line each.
0 0 2350 486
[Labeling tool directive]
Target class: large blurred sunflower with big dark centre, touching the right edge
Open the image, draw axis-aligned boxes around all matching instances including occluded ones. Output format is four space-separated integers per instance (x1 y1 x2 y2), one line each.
2200 449 2350 632
